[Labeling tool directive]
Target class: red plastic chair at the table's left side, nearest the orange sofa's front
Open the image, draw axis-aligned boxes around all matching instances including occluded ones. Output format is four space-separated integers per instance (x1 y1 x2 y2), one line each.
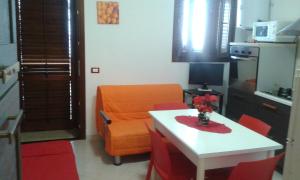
146 127 196 180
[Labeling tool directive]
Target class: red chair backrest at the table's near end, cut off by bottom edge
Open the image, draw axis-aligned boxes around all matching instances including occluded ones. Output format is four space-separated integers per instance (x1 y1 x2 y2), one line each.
228 153 284 180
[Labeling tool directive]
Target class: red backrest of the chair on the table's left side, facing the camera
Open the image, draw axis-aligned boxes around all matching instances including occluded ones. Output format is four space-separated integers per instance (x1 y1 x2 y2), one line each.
148 127 171 179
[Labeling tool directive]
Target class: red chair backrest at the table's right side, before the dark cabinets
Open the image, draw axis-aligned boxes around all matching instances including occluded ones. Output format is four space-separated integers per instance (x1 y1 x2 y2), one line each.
239 114 271 136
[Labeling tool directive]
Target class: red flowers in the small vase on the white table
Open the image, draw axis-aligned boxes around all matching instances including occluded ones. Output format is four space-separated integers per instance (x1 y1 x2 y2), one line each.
193 94 218 113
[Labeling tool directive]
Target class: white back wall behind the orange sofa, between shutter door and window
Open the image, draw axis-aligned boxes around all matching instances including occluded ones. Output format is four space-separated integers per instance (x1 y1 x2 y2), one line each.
84 0 188 135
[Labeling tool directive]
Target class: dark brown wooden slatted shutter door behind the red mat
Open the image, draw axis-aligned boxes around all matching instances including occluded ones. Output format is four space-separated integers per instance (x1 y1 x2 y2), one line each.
19 0 75 131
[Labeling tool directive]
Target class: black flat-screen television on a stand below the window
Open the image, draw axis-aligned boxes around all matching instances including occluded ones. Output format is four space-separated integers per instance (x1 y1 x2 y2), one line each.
189 63 224 89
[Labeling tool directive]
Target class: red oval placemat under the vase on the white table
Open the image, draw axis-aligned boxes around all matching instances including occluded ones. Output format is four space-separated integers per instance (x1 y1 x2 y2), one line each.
175 116 231 134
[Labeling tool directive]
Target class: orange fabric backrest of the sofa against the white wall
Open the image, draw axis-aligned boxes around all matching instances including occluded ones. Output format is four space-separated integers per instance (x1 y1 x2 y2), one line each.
98 84 183 119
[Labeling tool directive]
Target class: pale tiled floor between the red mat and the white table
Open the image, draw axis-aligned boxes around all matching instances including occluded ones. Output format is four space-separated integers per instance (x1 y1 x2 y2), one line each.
73 137 282 180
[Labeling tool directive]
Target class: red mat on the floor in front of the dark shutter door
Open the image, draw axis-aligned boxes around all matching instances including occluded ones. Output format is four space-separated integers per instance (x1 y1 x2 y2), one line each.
21 141 79 180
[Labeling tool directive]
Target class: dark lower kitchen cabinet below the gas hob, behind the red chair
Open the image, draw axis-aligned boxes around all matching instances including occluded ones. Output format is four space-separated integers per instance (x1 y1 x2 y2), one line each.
226 87 291 171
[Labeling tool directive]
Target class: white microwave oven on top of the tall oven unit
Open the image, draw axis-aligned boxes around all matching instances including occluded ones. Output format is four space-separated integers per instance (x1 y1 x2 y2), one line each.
252 21 296 43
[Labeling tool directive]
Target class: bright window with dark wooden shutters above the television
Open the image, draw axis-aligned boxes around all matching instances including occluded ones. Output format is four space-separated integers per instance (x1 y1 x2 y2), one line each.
172 0 236 61
